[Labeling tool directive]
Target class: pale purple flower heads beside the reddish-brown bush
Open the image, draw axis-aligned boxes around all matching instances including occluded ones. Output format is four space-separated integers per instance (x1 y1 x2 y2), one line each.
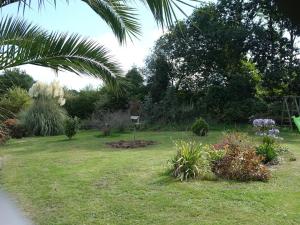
253 119 280 138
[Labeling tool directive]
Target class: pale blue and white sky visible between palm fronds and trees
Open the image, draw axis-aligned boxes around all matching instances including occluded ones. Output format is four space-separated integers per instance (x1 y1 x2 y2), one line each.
0 0 202 90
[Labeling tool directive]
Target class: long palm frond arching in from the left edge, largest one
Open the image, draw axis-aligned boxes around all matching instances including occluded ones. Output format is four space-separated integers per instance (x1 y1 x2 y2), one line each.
0 18 121 86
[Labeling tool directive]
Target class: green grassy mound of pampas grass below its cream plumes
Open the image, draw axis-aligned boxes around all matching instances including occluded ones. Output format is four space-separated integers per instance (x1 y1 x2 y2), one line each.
20 99 66 136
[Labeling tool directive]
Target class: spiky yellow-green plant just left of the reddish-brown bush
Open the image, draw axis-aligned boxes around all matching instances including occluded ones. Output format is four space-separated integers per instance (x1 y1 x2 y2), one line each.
170 141 213 181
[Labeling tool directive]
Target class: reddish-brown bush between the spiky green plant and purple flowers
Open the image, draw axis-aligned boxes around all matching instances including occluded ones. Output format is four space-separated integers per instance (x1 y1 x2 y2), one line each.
213 133 271 181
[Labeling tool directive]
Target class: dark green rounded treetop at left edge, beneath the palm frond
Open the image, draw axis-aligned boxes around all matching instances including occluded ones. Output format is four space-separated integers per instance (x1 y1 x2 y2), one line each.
0 69 34 94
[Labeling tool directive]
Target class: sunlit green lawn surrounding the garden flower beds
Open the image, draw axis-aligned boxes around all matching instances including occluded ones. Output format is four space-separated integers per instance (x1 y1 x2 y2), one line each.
0 131 300 225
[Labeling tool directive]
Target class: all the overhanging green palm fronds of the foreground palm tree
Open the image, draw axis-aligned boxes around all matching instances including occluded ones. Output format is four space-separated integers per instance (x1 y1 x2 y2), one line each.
0 0 197 84
